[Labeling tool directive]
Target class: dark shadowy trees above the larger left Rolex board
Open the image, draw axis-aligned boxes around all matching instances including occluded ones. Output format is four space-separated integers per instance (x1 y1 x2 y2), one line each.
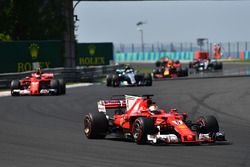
0 0 66 41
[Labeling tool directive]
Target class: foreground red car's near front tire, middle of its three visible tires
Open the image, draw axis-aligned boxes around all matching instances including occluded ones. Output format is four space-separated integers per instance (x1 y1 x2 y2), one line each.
132 117 157 144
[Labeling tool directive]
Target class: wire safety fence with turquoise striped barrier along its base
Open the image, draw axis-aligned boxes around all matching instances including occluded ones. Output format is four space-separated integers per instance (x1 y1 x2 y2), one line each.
114 41 250 62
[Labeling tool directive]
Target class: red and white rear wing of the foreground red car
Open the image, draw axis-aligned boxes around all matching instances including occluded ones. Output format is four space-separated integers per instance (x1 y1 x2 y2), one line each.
97 99 126 113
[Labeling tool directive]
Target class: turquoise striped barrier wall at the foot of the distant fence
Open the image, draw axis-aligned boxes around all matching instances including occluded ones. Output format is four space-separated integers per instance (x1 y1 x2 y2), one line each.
114 52 194 62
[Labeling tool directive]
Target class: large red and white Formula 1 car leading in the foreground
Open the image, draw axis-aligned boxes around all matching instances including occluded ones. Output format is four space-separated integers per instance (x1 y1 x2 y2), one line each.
84 95 225 144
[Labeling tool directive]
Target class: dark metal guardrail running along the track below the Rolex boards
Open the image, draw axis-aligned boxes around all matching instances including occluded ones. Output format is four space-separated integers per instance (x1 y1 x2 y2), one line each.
0 65 120 88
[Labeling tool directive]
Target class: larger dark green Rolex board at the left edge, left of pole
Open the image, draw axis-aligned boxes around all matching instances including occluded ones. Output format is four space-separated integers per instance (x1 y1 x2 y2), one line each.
0 41 63 73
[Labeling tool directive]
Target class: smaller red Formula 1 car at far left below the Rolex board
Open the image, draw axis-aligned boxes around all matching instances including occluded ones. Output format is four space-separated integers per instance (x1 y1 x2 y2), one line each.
10 72 66 96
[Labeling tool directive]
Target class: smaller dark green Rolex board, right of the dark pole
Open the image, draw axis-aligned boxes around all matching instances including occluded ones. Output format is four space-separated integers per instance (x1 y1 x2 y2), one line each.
76 43 113 66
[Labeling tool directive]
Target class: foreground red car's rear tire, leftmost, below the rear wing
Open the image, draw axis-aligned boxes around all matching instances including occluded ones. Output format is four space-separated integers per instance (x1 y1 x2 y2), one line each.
83 112 108 139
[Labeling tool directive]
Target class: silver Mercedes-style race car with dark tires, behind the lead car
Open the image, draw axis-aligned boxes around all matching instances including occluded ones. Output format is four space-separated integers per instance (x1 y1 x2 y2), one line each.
106 66 152 87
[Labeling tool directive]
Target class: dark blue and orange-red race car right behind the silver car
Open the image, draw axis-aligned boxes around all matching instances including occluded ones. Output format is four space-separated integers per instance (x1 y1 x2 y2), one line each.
153 58 188 78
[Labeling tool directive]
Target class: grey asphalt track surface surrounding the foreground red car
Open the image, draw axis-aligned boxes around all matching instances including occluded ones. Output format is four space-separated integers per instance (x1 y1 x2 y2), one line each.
0 63 250 167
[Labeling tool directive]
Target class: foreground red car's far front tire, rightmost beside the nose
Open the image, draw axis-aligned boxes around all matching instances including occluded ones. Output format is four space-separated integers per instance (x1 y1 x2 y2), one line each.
197 115 219 133
